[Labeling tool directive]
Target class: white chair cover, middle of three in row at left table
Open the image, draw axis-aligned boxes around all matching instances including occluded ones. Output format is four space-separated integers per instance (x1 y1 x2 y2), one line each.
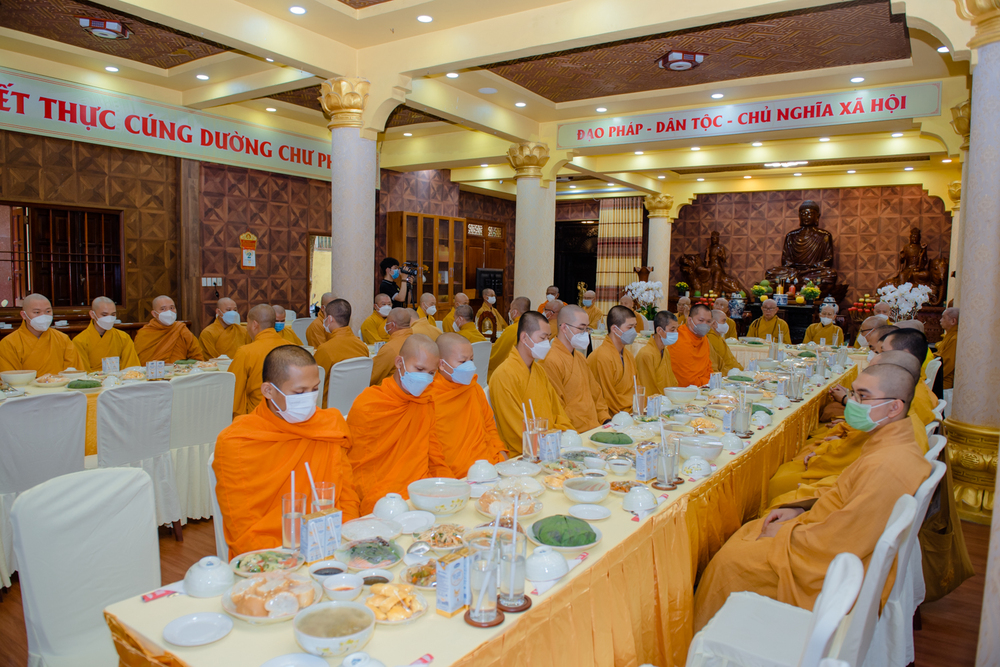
97 382 181 525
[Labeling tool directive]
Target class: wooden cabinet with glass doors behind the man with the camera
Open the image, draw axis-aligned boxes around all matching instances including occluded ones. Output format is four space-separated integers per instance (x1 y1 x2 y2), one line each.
386 211 465 318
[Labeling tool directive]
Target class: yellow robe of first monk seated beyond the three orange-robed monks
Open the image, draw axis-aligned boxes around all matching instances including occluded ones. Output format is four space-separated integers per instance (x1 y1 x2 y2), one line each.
489 350 573 455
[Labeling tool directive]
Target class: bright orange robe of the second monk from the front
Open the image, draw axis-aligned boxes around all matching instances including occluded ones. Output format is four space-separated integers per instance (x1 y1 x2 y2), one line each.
347 378 457 516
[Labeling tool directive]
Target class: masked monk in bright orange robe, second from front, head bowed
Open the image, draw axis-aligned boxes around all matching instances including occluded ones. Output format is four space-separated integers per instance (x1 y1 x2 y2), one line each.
347 336 456 516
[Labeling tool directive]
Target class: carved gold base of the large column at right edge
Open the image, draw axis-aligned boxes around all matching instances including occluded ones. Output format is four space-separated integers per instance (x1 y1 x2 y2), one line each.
944 419 1000 526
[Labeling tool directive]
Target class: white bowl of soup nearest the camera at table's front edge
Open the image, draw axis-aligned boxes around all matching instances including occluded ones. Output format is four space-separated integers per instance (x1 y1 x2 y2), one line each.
292 601 375 658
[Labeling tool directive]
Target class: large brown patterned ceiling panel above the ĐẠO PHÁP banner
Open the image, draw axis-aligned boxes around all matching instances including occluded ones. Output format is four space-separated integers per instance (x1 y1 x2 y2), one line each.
485 0 910 102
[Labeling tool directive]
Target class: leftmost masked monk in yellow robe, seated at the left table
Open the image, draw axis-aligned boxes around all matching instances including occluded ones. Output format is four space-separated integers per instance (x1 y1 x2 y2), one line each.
0 294 83 377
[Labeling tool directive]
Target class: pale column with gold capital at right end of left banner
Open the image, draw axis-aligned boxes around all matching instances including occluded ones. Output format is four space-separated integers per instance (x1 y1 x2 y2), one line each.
319 77 377 330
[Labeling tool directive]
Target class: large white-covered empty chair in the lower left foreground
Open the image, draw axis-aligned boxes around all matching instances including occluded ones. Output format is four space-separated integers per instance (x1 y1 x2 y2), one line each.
11 468 160 667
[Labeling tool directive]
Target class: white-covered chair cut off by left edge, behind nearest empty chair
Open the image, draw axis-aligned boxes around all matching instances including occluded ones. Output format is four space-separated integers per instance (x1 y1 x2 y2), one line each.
0 391 87 588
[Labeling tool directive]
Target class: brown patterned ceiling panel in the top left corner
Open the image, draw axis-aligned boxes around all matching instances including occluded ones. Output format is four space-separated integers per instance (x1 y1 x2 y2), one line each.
0 0 229 69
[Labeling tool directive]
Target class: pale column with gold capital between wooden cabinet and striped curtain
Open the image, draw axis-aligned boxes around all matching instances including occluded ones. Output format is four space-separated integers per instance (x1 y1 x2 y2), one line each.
507 141 556 307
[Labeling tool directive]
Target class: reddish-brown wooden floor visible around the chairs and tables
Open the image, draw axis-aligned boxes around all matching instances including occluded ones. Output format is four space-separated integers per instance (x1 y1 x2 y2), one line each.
0 520 990 667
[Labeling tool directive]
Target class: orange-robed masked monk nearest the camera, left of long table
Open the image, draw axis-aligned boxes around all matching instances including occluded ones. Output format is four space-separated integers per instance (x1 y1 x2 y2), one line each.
212 345 359 557
